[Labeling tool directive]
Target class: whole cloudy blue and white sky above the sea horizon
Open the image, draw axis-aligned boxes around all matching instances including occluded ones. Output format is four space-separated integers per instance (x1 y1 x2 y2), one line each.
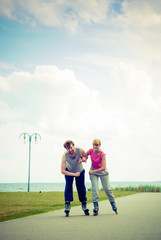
0 0 161 183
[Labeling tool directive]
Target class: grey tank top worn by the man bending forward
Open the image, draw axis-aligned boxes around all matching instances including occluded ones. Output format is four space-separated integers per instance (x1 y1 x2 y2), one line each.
65 148 84 173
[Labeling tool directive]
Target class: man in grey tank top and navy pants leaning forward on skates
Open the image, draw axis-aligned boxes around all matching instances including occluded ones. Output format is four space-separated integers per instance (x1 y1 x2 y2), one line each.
61 140 89 216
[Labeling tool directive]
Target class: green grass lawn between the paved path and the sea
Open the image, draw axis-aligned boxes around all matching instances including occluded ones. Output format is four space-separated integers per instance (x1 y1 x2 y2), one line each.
0 191 136 222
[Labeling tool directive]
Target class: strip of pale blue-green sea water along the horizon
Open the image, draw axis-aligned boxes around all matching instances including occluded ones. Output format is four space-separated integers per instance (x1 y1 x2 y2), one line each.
0 181 161 192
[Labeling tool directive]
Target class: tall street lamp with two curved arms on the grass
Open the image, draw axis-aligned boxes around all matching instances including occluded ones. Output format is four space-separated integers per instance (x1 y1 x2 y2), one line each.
19 133 41 192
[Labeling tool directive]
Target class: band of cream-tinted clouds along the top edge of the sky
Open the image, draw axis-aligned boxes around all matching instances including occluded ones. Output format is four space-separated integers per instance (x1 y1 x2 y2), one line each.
0 0 161 35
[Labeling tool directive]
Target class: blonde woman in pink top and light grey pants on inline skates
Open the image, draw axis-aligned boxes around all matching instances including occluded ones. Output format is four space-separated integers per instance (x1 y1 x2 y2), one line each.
86 139 117 215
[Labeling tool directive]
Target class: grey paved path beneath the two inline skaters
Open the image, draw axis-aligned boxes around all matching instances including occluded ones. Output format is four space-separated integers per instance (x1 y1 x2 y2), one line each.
0 193 161 240
